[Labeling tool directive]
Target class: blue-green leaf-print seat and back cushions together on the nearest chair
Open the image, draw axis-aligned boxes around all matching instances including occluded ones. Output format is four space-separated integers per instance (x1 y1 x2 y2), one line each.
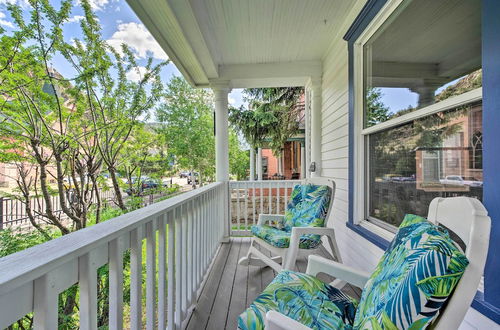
238 214 469 329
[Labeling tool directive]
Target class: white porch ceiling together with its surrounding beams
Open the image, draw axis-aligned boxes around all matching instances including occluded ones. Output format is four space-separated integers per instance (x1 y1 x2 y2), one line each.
127 0 356 87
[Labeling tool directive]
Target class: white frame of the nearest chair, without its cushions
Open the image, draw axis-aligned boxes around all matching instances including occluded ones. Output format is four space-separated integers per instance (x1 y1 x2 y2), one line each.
266 197 491 330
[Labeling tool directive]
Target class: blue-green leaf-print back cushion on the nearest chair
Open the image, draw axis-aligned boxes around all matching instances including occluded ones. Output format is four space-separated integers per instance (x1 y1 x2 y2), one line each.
354 215 469 329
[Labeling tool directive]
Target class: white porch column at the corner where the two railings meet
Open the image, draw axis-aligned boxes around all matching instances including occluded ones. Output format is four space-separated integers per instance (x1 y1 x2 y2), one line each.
212 84 231 242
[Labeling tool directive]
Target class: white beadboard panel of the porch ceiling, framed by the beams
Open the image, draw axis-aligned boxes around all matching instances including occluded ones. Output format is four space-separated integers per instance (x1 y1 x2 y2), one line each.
190 0 353 65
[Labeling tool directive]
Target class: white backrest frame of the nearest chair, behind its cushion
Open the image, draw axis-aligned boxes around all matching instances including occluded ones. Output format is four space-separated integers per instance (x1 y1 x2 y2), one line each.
427 197 491 329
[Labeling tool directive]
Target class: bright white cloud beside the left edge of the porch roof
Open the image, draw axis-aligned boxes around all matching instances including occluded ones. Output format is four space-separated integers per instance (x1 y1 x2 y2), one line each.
108 22 168 60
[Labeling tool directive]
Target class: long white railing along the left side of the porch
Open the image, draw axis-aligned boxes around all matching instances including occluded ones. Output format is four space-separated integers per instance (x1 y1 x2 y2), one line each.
0 183 227 329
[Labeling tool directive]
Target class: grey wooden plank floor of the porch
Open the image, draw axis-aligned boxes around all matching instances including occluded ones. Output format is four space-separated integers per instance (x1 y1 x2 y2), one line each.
187 238 360 330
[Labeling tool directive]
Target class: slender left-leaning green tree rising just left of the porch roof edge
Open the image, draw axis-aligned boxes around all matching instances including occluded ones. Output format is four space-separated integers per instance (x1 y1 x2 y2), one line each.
64 1 168 210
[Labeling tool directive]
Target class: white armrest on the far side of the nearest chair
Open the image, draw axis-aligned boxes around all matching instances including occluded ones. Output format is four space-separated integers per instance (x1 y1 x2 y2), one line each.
306 255 371 288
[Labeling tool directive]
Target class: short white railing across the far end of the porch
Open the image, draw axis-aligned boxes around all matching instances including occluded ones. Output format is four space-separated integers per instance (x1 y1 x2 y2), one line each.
229 180 300 236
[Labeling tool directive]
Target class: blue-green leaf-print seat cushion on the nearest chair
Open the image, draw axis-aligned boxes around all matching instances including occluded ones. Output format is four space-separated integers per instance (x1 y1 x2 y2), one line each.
238 270 357 330
